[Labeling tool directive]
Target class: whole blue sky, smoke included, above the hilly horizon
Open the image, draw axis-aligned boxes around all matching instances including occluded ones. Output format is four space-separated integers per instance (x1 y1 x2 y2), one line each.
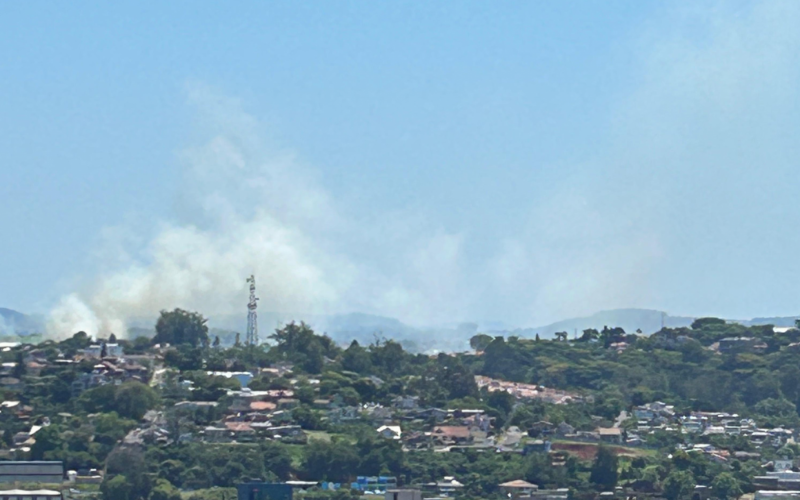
0 0 800 335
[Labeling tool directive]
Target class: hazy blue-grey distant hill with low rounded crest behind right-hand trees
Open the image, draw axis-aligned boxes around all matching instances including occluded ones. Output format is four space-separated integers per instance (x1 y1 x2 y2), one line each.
508 309 694 338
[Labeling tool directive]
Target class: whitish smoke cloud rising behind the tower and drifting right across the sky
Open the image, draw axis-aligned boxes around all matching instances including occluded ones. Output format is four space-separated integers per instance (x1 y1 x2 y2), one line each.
49 2 800 335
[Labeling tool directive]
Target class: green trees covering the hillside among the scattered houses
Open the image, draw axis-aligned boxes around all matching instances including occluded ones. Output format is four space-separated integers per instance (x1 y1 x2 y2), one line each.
0 309 800 500
